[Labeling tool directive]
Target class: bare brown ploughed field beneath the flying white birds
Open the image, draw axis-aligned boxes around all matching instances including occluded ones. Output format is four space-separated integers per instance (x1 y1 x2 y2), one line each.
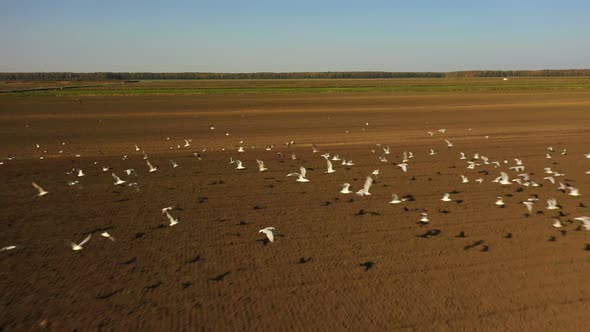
0 83 590 331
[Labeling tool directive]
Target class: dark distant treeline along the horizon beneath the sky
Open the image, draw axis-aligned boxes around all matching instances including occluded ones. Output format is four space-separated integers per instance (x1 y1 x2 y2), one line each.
0 69 590 81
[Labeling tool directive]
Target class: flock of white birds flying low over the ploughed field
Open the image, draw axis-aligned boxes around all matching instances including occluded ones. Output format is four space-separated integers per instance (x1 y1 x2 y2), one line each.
0 123 590 260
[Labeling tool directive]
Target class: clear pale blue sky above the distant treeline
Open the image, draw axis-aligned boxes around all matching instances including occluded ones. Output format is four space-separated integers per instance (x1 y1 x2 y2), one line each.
0 0 590 72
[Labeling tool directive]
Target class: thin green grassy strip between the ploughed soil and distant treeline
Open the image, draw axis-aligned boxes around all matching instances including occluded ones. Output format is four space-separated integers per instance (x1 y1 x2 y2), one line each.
0 77 590 97
